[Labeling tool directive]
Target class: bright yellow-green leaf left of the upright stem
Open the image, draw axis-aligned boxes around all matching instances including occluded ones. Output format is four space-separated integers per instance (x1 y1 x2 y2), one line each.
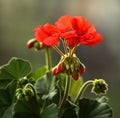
29 66 47 80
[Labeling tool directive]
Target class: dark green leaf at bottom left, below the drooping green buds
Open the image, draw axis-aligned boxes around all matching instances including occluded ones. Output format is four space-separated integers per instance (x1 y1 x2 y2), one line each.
13 98 40 118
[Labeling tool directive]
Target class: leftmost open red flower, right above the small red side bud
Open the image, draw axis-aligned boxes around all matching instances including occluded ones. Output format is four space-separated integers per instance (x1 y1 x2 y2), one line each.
34 23 59 46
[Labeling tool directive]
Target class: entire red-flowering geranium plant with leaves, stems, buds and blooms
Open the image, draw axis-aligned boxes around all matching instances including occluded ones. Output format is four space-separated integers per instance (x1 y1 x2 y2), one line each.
0 15 112 118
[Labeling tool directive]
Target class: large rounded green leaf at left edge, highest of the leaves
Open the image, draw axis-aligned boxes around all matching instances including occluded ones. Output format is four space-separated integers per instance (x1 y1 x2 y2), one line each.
0 57 31 88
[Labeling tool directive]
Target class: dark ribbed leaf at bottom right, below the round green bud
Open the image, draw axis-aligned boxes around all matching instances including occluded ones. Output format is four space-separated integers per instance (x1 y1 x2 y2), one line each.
79 98 112 118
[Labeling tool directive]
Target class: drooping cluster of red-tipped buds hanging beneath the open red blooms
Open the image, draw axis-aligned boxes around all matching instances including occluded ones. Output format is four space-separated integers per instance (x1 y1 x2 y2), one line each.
53 54 85 80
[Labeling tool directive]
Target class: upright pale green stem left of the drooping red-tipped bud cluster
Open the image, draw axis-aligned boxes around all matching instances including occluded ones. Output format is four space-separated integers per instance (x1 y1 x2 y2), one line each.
46 47 52 71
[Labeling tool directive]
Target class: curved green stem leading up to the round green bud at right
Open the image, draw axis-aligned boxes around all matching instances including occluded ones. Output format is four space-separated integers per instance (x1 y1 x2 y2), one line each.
74 80 93 103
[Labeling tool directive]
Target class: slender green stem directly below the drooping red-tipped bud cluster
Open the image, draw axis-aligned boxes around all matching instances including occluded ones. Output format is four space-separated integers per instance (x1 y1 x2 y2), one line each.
60 75 71 108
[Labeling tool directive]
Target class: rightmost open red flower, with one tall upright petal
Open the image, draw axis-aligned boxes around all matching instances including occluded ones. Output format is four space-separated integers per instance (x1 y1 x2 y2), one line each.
66 16 102 47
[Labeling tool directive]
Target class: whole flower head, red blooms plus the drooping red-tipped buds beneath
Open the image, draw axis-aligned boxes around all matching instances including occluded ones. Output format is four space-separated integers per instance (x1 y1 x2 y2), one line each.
28 15 102 80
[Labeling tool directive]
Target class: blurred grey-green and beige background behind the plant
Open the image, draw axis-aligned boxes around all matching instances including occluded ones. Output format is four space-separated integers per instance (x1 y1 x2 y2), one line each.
0 0 120 118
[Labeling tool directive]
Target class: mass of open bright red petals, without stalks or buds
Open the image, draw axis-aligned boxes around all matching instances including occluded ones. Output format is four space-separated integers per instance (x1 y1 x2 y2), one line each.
34 15 102 48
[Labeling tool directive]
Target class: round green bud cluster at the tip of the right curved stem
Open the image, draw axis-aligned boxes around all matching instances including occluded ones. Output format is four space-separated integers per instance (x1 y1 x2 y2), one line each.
92 79 108 95
